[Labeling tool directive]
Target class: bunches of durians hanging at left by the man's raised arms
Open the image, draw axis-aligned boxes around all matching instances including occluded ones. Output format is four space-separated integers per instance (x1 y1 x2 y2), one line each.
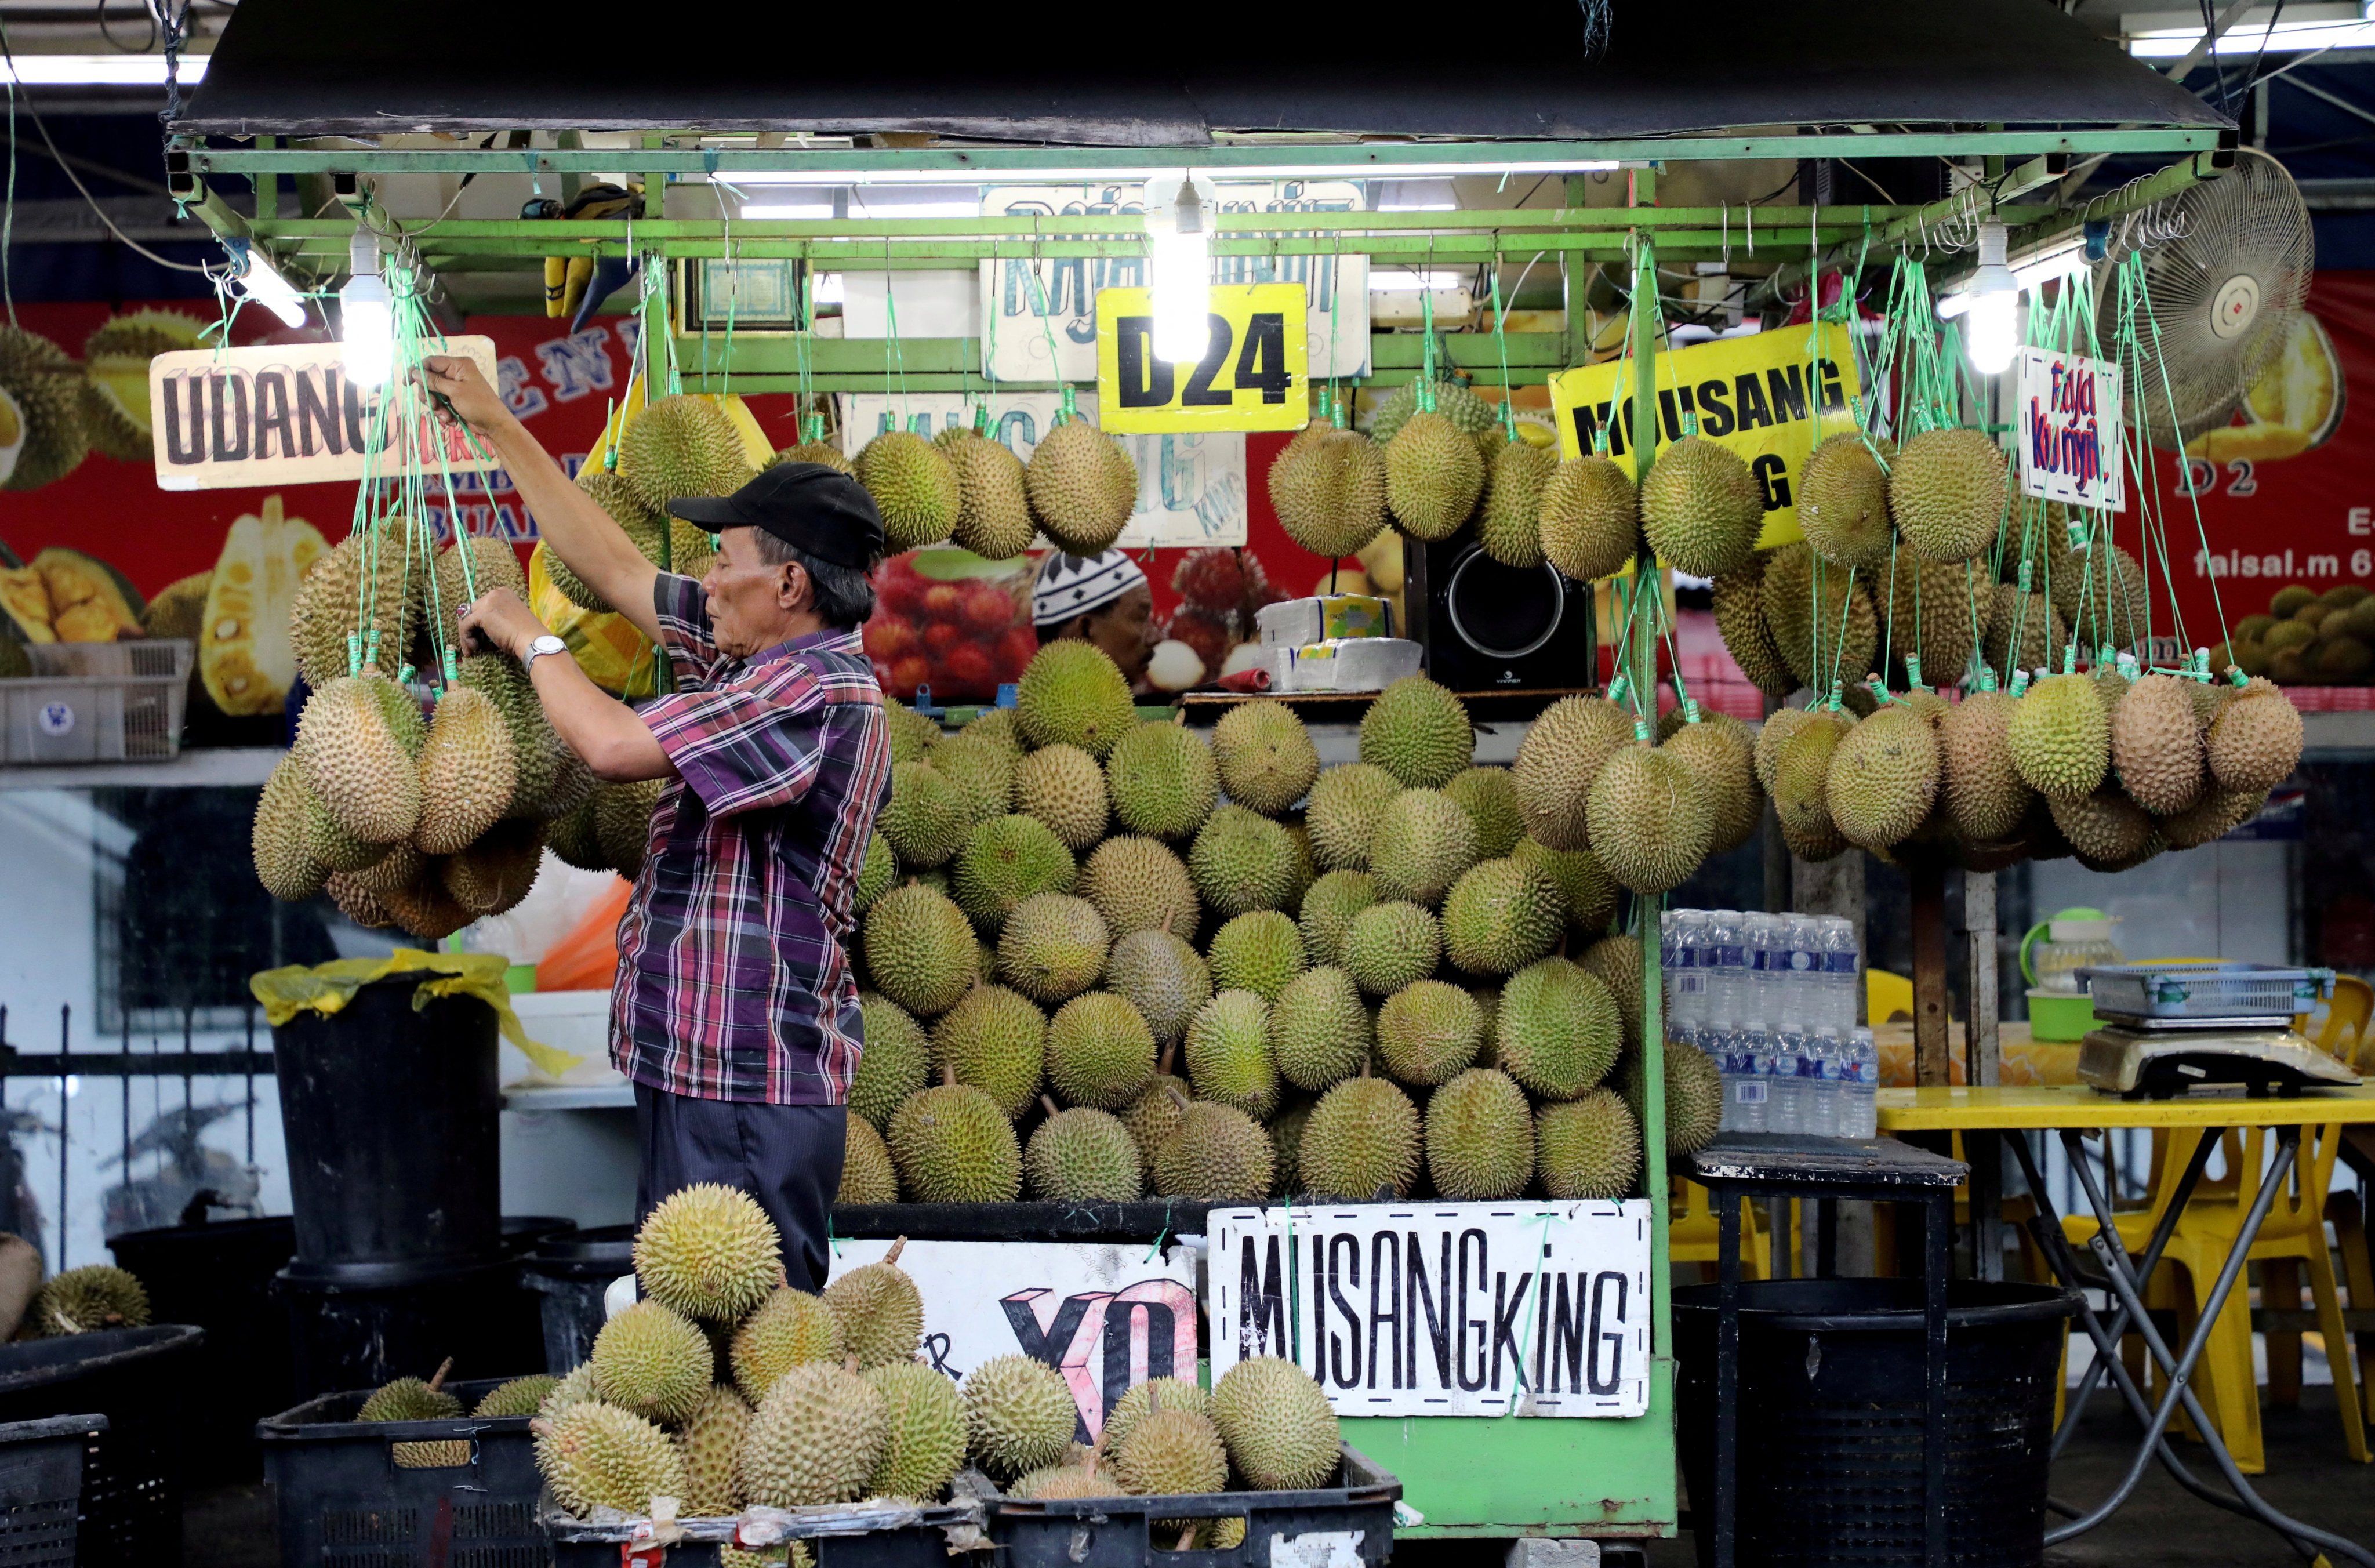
254 397 753 941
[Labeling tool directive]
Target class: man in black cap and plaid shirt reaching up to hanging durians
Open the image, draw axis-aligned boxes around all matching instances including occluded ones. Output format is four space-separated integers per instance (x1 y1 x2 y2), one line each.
425 359 891 1290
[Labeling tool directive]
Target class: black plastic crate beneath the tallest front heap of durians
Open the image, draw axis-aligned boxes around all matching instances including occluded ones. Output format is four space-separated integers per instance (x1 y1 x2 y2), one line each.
539 1483 988 1568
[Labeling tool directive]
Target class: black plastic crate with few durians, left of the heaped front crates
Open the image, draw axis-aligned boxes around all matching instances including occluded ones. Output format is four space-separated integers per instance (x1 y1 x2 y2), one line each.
256 1378 551 1568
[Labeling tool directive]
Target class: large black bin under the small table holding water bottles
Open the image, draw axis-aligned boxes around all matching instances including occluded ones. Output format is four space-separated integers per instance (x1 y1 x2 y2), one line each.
1675 1280 2076 1568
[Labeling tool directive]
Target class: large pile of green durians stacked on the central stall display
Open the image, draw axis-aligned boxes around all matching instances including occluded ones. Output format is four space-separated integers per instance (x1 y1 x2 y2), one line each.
841 641 1760 1202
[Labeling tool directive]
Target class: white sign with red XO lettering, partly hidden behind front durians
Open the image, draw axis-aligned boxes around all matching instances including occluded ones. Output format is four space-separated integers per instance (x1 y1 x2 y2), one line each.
831 1240 1197 1442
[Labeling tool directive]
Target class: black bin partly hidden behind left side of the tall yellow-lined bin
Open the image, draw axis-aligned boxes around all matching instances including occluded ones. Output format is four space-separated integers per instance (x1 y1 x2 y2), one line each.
107 1214 297 1485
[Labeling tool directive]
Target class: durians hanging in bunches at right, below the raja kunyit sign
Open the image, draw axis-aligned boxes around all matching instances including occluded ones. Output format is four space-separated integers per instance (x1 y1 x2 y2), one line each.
1710 430 2301 872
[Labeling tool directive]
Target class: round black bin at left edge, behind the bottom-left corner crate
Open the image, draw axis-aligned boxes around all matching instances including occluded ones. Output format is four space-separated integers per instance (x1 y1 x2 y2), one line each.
0 1323 204 1568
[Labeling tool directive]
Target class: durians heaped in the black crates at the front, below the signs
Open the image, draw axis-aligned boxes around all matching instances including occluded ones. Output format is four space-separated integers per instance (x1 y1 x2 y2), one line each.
446 1185 1339 1544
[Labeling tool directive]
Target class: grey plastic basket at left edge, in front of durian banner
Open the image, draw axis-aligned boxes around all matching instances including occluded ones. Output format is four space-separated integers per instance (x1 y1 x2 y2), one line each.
0 637 193 763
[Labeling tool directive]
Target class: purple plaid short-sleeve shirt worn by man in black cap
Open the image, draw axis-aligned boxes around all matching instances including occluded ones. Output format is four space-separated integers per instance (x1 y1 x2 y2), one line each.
611 572 891 1105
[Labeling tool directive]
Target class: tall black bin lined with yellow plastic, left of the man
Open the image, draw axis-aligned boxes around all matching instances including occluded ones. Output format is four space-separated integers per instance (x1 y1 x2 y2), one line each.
273 974 503 1288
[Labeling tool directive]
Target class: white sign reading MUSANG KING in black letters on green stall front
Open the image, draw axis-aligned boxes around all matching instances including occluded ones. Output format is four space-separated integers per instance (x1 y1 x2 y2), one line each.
1204 1197 1651 1416
